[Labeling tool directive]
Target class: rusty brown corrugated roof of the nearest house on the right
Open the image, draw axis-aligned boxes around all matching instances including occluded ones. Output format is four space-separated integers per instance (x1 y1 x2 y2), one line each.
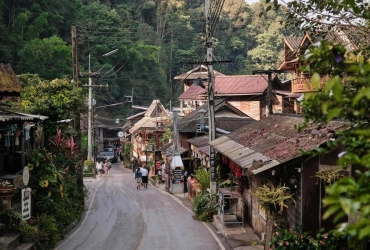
210 114 346 174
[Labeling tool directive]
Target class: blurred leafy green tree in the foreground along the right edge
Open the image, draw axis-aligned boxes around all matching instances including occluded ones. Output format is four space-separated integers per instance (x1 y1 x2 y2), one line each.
289 1 370 249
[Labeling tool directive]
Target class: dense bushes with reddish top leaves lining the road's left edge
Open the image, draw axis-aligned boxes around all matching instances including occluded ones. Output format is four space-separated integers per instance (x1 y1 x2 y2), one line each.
27 130 84 249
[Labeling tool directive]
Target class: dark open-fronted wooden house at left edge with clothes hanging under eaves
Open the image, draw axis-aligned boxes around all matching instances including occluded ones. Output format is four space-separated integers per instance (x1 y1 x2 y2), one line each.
0 64 48 188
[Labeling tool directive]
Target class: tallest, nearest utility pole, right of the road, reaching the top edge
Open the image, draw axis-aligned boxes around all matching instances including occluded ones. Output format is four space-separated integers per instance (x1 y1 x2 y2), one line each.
205 0 217 193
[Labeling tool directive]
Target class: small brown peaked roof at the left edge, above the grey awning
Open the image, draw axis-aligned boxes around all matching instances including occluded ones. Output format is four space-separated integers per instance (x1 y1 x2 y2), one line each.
0 63 22 95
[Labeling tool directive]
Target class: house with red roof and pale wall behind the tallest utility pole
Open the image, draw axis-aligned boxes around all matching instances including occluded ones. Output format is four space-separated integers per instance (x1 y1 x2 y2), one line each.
178 75 291 120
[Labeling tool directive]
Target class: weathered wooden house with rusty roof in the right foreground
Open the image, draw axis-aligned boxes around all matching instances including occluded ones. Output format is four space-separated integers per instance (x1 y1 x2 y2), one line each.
210 114 346 241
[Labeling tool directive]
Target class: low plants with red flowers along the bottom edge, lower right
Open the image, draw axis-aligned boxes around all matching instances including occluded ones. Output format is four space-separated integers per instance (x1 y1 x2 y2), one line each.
270 225 340 250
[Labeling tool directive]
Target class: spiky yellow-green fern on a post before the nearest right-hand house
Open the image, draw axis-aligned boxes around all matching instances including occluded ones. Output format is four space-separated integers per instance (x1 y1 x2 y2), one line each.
253 183 295 216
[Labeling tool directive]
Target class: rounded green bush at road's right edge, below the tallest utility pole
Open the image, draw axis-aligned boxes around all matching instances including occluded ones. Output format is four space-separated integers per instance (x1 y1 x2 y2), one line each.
193 192 218 221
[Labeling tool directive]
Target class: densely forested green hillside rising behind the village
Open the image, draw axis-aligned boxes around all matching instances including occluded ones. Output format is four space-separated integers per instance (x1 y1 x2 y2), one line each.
0 0 292 117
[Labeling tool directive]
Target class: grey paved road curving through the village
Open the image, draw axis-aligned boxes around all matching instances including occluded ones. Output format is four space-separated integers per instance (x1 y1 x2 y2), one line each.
55 163 224 250
